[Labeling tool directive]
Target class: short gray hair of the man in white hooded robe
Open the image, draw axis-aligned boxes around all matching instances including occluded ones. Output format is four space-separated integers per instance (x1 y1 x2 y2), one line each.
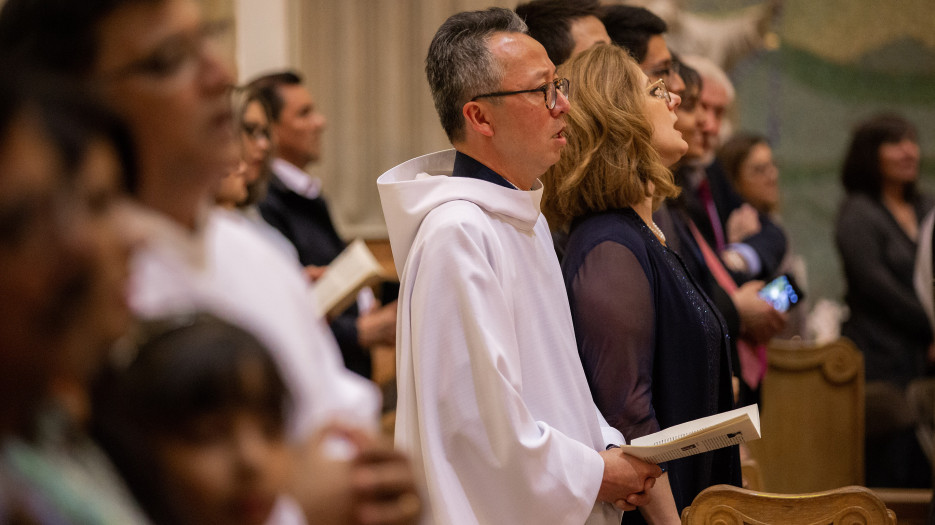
425 7 527 143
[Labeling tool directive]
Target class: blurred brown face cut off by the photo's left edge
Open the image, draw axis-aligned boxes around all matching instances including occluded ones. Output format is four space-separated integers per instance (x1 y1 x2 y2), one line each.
0 116 80 433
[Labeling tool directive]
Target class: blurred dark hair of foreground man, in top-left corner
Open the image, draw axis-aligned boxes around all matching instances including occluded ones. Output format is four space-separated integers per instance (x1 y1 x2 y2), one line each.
0 0 165 77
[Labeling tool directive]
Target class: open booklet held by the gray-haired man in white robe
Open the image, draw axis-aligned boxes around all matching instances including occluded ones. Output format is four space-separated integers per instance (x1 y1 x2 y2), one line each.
620 404 760 463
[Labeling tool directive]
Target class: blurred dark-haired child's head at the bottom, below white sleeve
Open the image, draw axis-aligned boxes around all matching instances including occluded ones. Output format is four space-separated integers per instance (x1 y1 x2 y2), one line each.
94 315 288 524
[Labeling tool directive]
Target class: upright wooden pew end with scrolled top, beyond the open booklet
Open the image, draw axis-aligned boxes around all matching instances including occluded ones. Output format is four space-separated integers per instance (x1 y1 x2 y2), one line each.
747 338 864 494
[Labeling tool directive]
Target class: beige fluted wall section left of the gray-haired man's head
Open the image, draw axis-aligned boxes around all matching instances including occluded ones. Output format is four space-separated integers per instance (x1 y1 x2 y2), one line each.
291 0 515 238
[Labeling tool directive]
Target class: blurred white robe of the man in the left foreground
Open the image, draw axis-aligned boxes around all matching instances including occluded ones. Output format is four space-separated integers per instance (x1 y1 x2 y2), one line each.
130 205 379 439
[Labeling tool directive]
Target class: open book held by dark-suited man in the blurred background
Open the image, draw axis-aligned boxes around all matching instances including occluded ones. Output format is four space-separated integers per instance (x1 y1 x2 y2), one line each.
312 239 396 317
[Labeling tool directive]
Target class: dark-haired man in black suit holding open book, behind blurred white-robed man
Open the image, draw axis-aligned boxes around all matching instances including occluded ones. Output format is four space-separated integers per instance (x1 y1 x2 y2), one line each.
250 71 396 377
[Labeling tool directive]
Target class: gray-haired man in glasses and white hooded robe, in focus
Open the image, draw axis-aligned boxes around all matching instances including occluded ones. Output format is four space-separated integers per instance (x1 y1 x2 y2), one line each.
378 8 661 525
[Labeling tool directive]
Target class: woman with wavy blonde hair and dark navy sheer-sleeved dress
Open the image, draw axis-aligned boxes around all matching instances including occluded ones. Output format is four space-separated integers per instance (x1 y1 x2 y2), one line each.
543 46 740 523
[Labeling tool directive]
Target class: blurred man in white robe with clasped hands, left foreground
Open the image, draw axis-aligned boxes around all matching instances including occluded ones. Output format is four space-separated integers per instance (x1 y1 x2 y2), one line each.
0 0 418 513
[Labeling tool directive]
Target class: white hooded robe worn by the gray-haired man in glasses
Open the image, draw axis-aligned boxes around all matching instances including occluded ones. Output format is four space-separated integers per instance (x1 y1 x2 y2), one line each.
377 150 623 524
